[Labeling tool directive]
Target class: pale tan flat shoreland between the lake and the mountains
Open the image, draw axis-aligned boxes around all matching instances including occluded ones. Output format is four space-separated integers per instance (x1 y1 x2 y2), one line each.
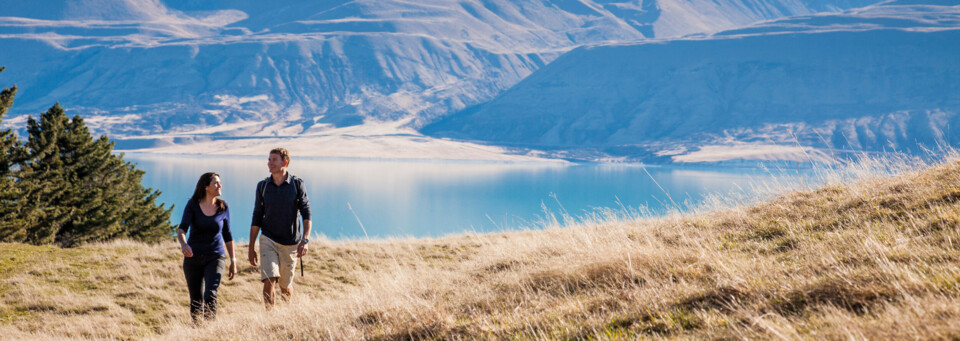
115 121 836 164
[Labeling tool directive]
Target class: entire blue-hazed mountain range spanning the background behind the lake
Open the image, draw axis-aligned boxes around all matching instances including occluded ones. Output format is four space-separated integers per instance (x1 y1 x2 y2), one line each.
0 0 957 161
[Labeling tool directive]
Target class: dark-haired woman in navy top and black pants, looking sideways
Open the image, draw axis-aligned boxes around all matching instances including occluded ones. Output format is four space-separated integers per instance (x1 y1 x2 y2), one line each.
177 172 237 323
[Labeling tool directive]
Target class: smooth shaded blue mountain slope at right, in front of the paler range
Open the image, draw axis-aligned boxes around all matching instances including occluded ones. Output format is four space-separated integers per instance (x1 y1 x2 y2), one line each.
423 1 960 160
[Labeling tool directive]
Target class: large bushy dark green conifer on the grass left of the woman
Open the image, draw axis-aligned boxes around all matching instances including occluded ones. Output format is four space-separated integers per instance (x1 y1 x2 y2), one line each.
19 103 174 247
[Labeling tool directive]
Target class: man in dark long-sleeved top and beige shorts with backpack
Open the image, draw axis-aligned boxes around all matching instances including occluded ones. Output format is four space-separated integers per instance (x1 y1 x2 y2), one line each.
247 148 311 310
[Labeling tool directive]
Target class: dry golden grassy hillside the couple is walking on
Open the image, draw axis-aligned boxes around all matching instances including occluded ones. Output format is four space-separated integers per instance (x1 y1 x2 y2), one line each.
0 161 960 340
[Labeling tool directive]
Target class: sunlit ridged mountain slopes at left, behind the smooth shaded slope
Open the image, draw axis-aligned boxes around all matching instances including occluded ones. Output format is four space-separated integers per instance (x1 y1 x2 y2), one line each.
0 0 874 141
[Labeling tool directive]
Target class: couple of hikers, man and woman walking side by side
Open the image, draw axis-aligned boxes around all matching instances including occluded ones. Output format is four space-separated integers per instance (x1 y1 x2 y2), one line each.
177 148 311 323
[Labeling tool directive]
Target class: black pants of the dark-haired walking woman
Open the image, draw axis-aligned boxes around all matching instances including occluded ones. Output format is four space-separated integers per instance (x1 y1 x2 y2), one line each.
183 254 227 321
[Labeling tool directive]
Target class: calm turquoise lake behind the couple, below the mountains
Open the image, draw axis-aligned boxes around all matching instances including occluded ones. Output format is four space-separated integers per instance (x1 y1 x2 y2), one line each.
124 154 808 241
